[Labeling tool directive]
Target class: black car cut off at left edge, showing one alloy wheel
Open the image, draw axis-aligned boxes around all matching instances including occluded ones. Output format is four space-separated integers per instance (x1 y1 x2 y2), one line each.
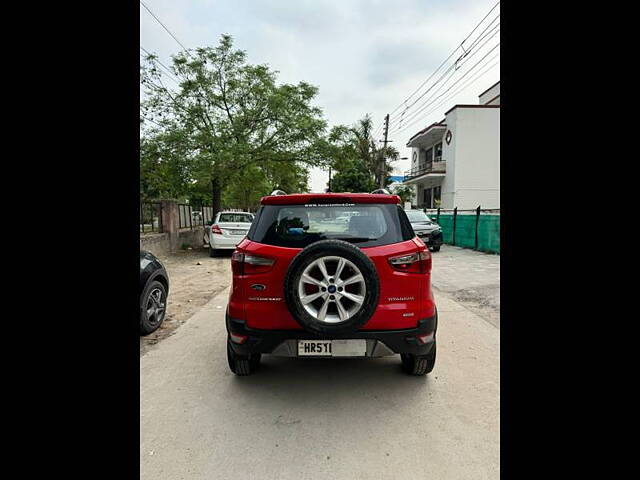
139 250 169 335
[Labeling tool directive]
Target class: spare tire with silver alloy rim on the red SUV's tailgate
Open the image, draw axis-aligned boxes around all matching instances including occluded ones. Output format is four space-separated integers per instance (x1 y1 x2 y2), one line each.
284 240 380 336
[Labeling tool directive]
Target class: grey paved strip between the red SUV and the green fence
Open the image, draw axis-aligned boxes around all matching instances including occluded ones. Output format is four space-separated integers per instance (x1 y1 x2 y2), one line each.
432 245 500 328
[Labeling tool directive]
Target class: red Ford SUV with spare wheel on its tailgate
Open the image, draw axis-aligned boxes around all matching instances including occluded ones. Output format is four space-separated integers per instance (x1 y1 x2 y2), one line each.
226 193 438 375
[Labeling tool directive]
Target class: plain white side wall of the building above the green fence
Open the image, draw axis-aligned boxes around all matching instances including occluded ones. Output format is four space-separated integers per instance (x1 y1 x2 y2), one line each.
442 107 500 209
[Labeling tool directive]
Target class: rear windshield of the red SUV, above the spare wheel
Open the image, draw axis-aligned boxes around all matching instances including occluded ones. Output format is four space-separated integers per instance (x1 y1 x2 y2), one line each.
248 204 413 248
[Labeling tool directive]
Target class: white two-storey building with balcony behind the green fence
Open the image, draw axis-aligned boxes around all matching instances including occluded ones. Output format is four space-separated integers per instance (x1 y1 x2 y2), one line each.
404 82 500 209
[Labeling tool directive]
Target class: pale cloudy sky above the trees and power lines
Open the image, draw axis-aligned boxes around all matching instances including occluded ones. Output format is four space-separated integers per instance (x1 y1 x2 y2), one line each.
140 0 500 192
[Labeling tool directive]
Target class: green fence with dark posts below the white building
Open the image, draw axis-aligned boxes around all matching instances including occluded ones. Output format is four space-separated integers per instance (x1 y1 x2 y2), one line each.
427 207 500 253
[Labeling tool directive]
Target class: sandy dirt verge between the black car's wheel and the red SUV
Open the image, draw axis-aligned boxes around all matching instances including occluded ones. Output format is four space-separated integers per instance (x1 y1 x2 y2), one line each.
140 248 231 356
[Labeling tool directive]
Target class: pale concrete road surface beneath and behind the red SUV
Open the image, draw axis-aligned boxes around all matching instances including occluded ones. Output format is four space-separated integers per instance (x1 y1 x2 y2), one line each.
140 276 500 480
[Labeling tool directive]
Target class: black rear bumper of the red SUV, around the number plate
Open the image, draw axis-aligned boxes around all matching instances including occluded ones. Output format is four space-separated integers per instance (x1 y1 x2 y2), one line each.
226 312 438 357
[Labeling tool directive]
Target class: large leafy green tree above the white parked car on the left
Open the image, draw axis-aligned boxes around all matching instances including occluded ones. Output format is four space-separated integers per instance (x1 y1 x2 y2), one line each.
141 35 326 210
